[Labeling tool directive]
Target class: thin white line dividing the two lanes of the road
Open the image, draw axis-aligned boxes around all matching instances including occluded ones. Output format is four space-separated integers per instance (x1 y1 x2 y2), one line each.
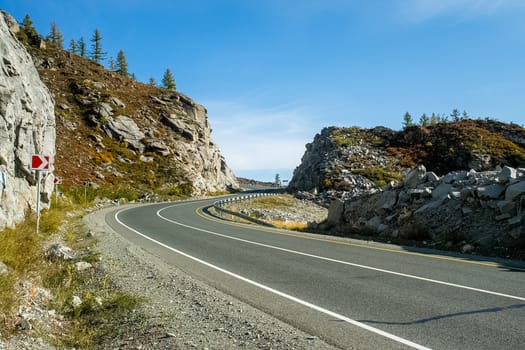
157 206 525 301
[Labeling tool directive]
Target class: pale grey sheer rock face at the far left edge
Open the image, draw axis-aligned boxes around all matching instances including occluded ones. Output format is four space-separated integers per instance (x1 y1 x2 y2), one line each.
0 12 55 229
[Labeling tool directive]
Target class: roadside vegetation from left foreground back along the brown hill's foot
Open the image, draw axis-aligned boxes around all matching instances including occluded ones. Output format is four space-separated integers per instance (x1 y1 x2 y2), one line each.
0 186 191 349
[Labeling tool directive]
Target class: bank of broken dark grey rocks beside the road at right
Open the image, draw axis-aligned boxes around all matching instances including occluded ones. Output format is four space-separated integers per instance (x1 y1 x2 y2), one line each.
325 166 525 258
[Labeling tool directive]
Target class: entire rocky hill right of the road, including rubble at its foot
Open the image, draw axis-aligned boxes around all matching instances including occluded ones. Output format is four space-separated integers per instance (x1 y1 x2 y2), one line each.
290 120 525 258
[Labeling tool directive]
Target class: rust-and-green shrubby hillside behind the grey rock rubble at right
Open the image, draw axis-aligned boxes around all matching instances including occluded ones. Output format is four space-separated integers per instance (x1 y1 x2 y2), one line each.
289 120 525 196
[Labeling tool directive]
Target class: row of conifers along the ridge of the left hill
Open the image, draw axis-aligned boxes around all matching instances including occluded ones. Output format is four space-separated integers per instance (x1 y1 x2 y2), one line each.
18 15 177 91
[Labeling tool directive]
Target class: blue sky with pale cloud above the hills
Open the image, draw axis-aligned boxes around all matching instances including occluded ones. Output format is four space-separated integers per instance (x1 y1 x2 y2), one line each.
0 0 525 180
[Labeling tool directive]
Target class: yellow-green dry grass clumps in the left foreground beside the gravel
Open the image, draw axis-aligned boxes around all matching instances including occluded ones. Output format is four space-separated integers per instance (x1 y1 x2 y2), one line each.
0 197 142 349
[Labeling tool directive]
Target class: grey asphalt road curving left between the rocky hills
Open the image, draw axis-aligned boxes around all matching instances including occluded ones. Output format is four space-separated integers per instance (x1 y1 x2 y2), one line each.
106 200 525 350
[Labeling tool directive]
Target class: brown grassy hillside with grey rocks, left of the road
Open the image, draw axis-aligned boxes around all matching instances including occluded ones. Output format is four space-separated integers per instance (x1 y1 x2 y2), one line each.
24 37 237 194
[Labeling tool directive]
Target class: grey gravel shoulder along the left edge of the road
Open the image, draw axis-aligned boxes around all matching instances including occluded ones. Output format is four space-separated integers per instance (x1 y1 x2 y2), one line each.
84 204 334 349
